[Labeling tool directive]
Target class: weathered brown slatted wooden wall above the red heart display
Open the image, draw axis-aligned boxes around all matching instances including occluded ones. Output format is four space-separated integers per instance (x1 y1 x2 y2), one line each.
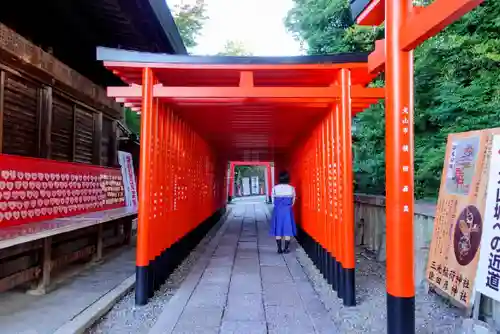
0 24 123 166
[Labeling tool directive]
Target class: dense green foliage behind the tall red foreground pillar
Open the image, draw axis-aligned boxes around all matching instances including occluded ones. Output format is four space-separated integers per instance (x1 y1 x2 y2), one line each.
285 0 500 198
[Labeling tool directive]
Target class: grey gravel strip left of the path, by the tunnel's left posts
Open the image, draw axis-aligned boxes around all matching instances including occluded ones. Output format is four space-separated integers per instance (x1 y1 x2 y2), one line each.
86 220 223 334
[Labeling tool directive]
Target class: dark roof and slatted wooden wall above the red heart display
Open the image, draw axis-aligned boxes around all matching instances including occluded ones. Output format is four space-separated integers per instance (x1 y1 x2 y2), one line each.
0 0 186 166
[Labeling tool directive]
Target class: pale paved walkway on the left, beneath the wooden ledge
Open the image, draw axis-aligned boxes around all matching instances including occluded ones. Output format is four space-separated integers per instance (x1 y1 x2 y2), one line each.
0 246 135 334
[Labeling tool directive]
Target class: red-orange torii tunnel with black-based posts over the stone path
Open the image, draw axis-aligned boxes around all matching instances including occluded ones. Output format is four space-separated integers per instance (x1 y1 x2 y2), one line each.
98 48 384 306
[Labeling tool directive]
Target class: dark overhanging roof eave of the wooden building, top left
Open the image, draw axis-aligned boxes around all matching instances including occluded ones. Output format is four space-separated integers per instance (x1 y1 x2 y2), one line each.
0 0 187 86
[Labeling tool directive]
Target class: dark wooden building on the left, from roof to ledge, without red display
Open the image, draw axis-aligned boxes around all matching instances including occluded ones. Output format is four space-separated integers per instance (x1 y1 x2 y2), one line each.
0 0 186 293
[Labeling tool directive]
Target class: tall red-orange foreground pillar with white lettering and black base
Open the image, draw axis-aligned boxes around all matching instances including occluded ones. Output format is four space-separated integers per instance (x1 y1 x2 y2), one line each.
351 0 483 334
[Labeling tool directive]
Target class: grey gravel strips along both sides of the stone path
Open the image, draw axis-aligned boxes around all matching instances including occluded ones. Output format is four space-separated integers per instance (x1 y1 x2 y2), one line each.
86 206 463 334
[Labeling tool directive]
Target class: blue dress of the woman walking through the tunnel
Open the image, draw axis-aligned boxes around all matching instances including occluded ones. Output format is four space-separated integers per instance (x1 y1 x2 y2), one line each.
269 196 297 237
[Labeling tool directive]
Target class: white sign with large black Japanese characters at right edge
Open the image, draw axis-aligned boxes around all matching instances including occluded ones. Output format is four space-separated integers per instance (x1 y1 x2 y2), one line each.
476 135 500 301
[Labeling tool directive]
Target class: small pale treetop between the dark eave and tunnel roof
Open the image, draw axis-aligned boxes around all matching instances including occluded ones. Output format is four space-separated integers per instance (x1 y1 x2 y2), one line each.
172 0 208 48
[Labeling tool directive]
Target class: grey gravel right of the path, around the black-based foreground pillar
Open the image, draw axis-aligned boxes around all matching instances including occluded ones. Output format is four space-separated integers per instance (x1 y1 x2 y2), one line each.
296 248 463 334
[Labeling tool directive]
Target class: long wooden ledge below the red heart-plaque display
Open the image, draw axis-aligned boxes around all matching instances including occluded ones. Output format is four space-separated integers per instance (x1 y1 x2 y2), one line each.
0 207 137 294
